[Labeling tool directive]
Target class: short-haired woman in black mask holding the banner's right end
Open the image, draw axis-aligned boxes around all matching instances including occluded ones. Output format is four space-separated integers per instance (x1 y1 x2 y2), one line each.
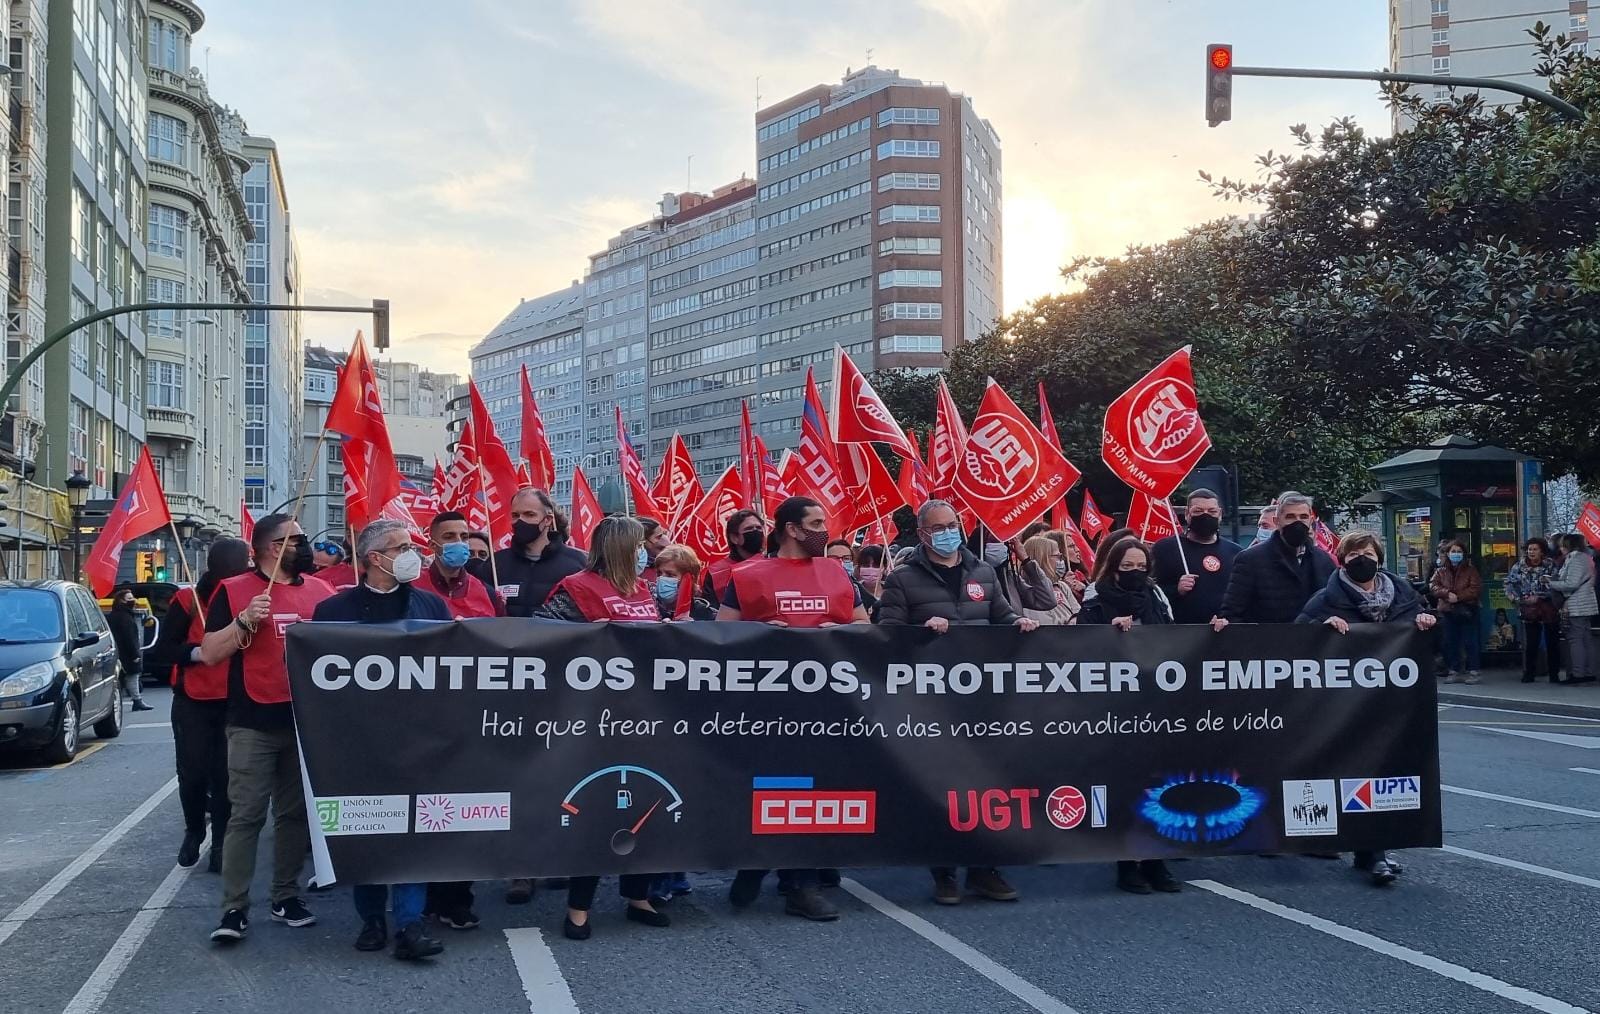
1296 531 1437 888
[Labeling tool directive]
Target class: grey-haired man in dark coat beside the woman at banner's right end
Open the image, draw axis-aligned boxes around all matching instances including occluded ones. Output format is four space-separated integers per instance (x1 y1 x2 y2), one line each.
1211 489 1334 630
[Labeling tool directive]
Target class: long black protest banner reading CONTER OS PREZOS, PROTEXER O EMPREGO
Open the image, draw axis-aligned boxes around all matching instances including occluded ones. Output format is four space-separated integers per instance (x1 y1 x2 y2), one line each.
288 619 1442 883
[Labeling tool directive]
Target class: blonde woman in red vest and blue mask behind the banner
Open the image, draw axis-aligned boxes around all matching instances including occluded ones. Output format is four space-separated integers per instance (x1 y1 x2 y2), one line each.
533 518 672 940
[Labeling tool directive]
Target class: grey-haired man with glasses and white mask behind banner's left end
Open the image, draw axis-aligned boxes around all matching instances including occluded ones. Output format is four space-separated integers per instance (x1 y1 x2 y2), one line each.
312 518 451 961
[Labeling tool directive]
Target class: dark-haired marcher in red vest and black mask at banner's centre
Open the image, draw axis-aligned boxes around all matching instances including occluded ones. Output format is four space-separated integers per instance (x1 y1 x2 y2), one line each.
717 496 869 923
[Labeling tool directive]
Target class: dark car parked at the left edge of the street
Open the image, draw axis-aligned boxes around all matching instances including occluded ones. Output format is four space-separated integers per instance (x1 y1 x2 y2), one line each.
0 581 122 764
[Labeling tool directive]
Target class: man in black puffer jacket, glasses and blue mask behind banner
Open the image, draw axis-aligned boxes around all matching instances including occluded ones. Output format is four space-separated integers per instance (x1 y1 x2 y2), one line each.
878 501 1038 905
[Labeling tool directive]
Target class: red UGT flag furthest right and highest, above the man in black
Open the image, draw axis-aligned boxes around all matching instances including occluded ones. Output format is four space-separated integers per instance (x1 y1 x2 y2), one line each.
1101 345 1211 501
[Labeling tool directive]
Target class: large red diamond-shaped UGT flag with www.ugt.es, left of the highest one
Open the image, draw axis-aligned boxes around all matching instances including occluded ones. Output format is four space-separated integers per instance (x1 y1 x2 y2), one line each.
955 379 1078 542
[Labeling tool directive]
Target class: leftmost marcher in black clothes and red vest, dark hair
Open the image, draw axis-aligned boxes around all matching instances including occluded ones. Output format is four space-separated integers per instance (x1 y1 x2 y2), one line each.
149 537 250 873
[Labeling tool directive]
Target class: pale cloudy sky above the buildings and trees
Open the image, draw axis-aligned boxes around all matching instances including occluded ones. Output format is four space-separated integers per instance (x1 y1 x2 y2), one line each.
192 0 1389 373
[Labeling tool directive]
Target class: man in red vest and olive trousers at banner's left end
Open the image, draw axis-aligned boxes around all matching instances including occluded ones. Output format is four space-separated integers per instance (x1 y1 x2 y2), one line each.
200 513 333 944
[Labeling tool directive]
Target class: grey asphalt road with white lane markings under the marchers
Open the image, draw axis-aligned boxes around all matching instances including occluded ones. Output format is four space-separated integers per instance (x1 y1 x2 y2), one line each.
0 691 1600 1014
